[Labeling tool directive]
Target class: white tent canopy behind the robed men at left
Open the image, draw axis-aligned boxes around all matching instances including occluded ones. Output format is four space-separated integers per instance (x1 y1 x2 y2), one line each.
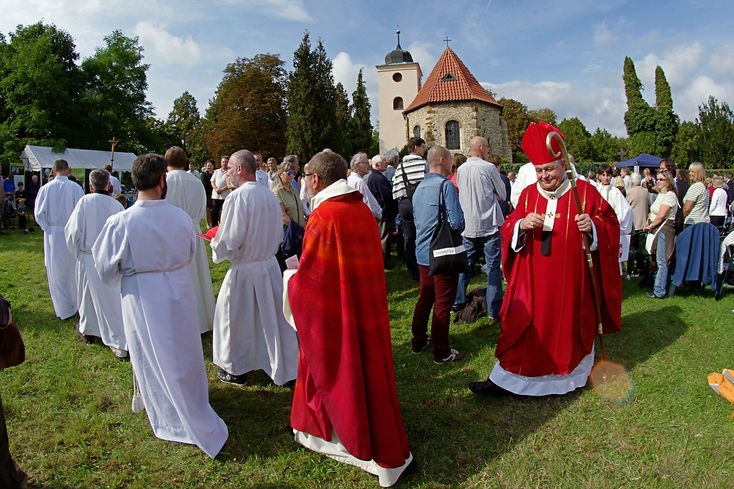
20 145 136 171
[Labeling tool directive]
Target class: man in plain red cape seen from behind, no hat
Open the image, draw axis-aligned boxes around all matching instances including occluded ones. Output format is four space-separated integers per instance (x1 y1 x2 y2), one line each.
287 151 413 487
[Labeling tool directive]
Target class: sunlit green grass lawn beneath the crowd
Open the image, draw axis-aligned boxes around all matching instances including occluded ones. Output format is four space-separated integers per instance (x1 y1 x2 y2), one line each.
0 222 734 489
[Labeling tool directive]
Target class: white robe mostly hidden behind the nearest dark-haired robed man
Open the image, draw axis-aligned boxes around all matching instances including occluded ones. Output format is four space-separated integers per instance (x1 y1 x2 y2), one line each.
166 170 214 333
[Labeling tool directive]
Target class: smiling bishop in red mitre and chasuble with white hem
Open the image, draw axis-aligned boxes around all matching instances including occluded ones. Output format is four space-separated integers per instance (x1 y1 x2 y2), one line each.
469 122 622 396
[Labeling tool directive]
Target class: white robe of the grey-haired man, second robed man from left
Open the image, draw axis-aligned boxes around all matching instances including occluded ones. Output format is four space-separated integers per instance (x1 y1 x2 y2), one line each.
64 193 127 350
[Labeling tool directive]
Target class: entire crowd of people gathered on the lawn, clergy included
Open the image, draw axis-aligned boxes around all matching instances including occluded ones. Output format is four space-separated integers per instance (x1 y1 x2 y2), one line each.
5 122 734 487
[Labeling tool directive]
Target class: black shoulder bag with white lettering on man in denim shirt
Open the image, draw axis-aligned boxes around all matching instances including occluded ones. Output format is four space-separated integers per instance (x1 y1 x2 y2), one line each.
428 180 467 276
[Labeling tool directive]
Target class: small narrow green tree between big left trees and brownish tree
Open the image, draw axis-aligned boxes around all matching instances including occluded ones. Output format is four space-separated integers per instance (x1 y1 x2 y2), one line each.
166 91 209 164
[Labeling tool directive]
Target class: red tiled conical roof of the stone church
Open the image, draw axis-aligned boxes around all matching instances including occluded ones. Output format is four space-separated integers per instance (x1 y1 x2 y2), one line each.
403 47 500 113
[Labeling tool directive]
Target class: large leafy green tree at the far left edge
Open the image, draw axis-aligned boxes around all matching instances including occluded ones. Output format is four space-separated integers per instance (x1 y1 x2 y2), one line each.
0 22 84 162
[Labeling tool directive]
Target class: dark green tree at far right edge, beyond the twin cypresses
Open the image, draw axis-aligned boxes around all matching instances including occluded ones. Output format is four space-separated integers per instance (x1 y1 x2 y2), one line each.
697 96 734 168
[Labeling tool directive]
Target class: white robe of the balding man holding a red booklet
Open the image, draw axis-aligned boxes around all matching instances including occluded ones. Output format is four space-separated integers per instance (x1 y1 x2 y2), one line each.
211 182 298 385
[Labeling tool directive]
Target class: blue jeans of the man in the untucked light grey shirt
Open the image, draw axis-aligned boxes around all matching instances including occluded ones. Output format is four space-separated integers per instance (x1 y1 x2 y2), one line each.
454 234 504 319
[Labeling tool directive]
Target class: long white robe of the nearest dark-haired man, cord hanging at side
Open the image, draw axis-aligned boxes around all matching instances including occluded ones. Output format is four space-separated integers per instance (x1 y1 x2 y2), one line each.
92 200 228 458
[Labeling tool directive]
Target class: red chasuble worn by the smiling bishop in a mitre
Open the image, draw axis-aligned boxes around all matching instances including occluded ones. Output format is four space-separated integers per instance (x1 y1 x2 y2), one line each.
495 181 622 377
